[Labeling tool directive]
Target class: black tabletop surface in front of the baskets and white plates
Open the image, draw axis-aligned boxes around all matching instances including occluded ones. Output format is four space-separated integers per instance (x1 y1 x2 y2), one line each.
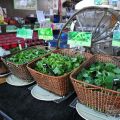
0 83 84 120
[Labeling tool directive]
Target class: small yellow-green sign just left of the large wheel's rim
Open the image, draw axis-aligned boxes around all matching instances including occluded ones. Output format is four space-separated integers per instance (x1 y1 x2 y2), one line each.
38 28 53 40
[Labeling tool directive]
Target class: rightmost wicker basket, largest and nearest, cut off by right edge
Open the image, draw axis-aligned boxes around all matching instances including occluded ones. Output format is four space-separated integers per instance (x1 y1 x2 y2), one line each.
70 55 120 115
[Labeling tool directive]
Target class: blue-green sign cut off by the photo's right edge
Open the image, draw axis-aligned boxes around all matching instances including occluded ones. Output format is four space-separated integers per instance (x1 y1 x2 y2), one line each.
112 30 120 47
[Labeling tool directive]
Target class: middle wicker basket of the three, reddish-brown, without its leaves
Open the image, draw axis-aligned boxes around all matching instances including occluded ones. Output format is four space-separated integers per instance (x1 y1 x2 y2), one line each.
27 49 92 96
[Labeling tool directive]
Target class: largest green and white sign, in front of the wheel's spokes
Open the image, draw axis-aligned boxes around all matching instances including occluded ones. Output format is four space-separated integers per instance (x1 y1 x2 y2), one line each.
68 32 92 47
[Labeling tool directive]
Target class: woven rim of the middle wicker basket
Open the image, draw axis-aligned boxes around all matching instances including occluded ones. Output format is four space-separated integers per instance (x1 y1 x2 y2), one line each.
27 48 92 78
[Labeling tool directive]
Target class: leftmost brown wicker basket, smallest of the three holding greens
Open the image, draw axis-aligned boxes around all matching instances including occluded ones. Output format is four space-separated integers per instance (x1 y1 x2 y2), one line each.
2 46 52 82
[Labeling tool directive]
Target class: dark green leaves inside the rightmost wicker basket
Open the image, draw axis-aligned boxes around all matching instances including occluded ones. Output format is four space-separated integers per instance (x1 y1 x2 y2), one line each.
77 62 120 89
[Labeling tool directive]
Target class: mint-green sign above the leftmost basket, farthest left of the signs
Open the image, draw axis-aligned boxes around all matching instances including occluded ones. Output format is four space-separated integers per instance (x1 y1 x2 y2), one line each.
17 28 33 39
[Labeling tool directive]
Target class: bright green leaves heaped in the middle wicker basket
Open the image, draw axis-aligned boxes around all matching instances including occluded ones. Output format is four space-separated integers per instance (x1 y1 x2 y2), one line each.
35 53 85 76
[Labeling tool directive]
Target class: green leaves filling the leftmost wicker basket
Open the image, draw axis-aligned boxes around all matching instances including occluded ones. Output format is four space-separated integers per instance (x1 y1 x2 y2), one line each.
6 48 47 64
